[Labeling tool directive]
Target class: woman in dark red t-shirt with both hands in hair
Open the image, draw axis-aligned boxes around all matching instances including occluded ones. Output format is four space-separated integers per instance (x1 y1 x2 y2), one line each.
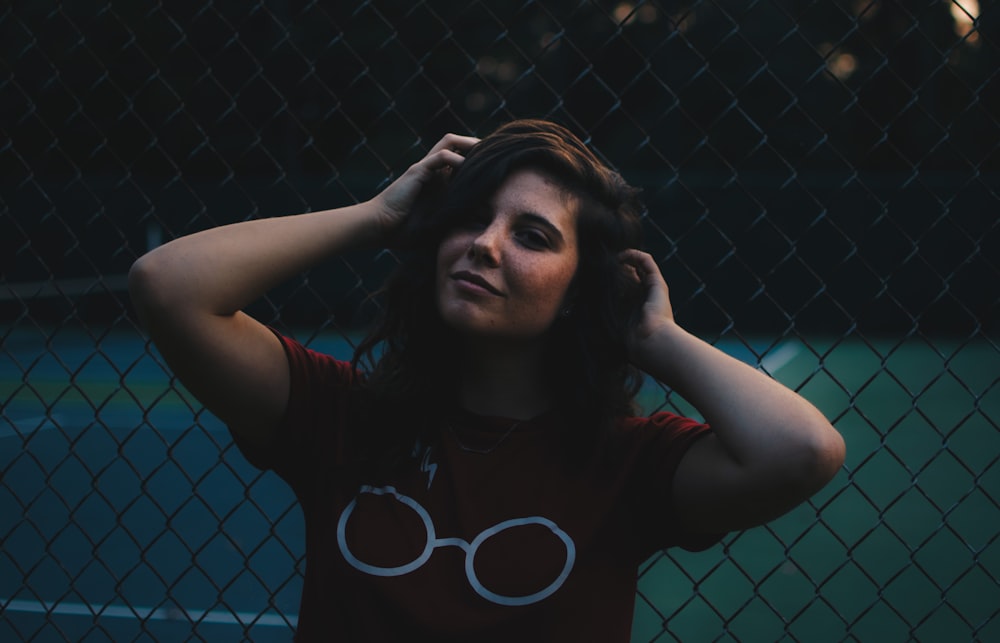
129 120 844 641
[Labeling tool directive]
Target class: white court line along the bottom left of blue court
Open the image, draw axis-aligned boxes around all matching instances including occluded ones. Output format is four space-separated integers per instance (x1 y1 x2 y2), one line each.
0 598 299 627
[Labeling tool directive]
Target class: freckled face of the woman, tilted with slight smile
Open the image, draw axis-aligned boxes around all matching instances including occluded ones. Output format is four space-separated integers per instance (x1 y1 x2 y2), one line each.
436 169 579 339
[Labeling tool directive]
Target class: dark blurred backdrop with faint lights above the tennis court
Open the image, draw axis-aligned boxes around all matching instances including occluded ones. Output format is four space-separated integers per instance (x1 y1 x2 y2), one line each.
0 0 1000 336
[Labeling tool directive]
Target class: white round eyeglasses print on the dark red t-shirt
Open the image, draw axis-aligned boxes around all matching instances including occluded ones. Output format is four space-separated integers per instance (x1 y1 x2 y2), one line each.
337 485 576 607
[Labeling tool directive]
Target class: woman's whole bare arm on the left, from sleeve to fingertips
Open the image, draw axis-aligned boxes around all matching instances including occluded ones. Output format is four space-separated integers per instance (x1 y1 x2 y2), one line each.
129 135 476 444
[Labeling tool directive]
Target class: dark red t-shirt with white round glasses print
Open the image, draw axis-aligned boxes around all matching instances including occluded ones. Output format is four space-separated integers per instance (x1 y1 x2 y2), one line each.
230 338 721 643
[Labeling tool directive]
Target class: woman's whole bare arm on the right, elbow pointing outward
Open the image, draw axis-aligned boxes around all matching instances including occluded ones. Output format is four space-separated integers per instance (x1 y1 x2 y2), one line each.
622 250 845 533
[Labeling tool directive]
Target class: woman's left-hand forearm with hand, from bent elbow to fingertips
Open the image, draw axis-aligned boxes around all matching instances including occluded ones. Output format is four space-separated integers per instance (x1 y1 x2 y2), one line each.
129 134 479 328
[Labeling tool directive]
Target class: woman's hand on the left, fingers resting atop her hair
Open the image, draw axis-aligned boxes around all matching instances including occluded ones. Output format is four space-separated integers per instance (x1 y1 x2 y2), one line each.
372 134 479 238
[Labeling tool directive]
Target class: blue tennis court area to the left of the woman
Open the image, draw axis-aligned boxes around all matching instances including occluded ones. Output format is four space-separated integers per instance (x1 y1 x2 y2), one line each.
0 331 303 641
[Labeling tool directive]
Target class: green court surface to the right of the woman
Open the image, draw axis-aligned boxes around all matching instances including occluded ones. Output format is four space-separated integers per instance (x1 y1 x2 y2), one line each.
633 337 1000 642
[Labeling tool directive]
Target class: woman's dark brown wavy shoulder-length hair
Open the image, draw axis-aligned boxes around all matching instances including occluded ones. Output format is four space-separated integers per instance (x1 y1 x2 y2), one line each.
353 120 642 476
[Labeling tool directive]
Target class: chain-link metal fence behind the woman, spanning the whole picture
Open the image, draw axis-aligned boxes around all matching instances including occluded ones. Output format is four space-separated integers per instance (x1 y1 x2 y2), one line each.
0 0 1000 641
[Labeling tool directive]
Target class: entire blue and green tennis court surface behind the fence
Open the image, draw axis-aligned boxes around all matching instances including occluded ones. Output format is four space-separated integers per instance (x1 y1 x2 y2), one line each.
0 328 1000 642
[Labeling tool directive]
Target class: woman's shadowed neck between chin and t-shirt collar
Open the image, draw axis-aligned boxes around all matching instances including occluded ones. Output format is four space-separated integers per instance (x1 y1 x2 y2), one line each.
459 342 552 420
